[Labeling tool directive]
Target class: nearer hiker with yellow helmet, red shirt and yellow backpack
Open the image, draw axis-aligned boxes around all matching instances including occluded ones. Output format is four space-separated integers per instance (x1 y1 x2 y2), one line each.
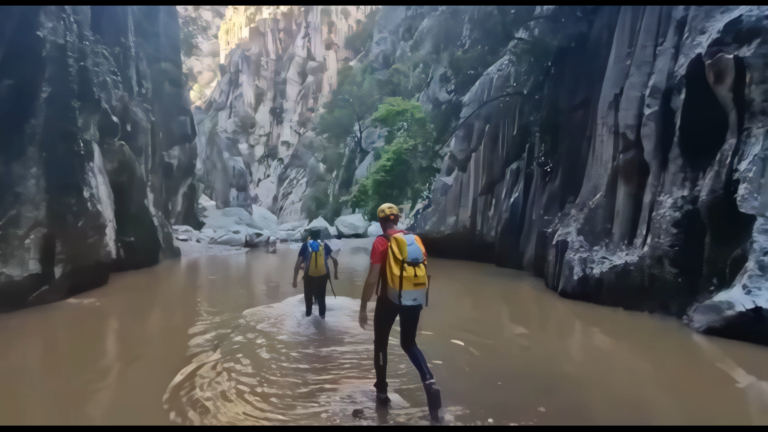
360 204 441 423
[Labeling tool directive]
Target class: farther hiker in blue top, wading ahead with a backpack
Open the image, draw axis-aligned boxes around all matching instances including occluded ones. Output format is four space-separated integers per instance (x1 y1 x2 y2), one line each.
293 230 339 319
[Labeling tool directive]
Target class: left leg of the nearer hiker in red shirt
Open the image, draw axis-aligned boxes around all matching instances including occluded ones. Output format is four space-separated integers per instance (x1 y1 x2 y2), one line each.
373 294 399 405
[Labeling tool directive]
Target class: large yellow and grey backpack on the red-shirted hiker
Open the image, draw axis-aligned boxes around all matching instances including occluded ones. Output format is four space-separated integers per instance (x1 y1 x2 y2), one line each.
377 233 429 306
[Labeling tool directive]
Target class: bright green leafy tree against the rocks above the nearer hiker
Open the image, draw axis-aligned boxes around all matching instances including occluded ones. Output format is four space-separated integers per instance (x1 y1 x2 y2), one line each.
349 98 440 220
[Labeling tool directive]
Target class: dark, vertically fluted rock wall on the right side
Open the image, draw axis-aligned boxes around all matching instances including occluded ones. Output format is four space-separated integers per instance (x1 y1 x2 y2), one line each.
414 6 768 344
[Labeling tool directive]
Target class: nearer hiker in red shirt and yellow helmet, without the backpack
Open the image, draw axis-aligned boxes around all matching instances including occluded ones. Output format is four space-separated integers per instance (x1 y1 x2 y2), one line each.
360 204 441 423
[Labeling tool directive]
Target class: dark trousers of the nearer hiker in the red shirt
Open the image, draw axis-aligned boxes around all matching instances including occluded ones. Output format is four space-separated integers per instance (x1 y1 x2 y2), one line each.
373 293 434 393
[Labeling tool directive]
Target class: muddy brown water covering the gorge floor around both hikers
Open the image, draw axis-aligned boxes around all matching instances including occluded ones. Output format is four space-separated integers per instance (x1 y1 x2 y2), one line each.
0 239 768 425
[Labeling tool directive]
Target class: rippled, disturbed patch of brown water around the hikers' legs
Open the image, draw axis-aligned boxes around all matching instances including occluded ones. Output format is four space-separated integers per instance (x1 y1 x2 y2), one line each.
164 295 460 424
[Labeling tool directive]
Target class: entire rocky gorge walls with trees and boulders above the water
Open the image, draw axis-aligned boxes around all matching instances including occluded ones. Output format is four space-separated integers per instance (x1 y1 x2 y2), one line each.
0 6 768 352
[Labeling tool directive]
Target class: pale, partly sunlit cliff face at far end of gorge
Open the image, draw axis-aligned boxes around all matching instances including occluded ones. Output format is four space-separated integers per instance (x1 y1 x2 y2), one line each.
188 6 336 223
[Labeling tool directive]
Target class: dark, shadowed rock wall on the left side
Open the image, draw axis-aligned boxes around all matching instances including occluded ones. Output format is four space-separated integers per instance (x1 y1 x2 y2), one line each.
0 6 199 309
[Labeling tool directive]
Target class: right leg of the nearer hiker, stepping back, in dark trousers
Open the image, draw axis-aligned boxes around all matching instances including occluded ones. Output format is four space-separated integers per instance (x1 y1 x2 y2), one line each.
400 306 442 422
